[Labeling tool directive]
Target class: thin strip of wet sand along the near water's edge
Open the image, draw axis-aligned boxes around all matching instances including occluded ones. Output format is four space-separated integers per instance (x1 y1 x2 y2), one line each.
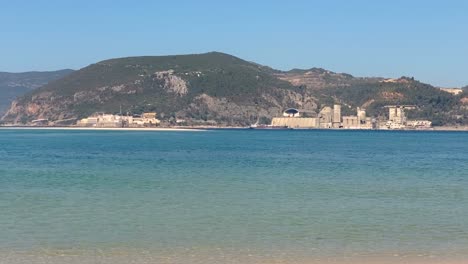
0 252 468 264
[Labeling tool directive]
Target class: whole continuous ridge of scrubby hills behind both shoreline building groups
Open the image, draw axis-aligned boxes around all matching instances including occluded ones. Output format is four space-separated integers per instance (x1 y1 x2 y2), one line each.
3 52 468 125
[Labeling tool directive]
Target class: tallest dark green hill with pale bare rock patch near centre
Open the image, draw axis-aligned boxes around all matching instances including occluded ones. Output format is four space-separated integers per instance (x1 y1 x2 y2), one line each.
4 52 295 124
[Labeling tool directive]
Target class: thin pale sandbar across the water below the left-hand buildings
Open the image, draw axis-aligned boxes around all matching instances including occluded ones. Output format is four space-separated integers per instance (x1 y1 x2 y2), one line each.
0 126 204 132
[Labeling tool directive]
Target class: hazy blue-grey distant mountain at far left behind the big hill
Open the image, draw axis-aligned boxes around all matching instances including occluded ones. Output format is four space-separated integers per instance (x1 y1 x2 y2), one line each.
0 70 73 115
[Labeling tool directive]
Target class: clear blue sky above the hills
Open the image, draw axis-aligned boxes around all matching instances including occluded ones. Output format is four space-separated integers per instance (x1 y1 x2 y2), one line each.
0 0 468 86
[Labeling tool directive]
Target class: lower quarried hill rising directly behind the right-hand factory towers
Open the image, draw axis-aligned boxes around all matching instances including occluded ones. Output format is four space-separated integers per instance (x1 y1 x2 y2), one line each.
314 78 468 125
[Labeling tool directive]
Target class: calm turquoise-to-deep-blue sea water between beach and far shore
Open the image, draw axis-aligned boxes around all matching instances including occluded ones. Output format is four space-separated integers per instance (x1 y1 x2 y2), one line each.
0 130 468 256
